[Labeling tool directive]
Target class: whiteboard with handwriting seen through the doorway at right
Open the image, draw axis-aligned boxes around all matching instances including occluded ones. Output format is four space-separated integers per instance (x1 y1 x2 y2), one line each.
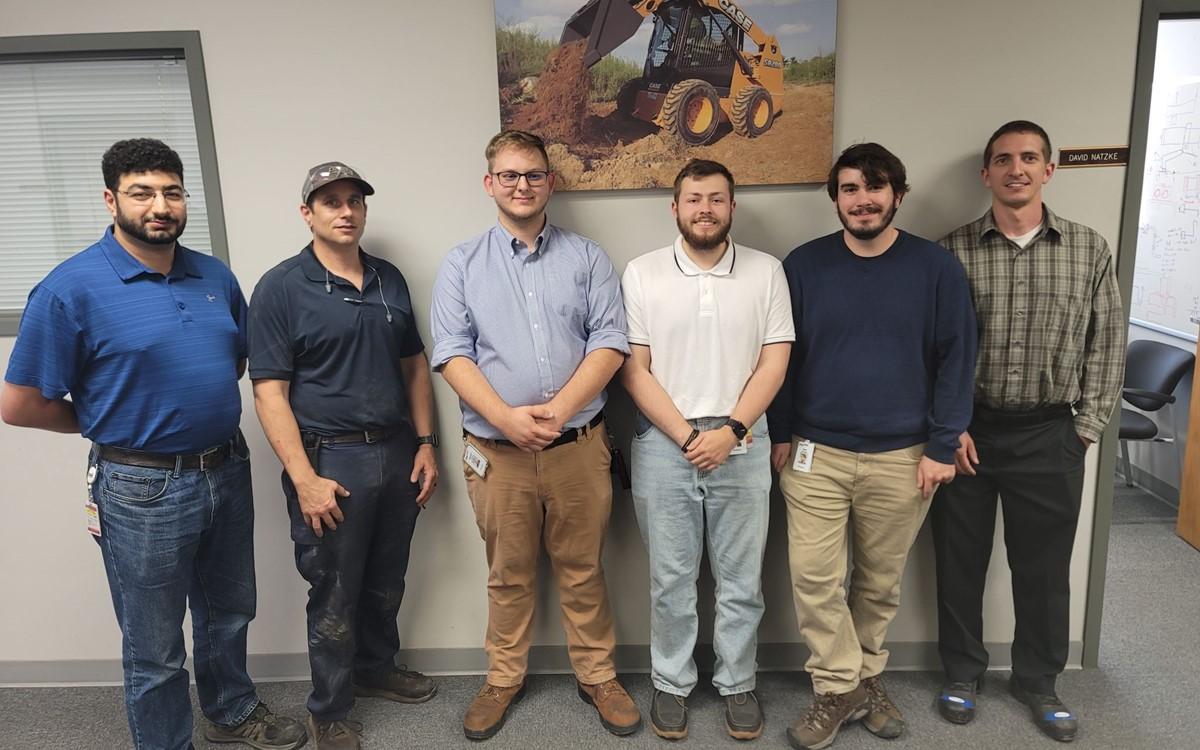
1129 19 1200 341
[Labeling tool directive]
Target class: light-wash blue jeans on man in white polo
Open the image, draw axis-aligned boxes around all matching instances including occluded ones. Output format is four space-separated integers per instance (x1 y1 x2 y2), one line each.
631 414 770 696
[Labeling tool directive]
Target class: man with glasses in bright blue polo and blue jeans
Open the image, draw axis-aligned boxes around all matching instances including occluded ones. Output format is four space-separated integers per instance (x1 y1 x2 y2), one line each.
0 138 305 750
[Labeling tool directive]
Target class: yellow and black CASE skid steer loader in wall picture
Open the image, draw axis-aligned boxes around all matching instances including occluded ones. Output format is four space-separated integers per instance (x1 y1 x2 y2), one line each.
560 0 784 145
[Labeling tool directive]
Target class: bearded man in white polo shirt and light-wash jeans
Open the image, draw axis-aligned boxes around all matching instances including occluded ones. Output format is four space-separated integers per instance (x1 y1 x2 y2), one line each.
622 160 796 739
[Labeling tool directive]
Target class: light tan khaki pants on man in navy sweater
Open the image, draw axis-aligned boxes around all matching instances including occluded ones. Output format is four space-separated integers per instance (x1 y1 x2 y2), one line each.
779 438 929 694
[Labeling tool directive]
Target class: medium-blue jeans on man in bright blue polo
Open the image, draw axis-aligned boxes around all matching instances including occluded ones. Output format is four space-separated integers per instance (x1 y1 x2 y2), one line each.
92 436 258 750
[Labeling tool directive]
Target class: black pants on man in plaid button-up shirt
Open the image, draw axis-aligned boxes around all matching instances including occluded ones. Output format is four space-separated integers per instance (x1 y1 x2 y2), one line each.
930 407 1086 692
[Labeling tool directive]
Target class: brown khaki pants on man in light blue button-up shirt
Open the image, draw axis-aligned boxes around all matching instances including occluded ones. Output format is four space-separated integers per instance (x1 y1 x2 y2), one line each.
463 422 617 688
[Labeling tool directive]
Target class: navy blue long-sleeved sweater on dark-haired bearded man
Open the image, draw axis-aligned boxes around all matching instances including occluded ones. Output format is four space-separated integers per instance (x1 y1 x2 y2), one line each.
767 232 977 463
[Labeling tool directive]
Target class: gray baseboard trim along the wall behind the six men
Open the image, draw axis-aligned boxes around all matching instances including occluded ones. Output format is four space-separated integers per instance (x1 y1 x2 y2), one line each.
0 641 1084 688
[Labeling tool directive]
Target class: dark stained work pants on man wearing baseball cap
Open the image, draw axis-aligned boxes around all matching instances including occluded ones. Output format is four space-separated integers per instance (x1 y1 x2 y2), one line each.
283 430 420 721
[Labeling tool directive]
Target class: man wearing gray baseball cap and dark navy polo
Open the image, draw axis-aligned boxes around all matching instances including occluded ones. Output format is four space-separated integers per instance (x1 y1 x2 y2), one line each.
250 162 438 750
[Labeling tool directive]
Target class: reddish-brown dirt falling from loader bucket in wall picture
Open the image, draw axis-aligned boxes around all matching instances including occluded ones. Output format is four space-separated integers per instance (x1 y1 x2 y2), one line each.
511 40 592 143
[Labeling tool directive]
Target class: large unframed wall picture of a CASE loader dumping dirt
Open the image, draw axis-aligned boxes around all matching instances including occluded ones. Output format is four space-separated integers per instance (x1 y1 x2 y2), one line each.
496 0 838 190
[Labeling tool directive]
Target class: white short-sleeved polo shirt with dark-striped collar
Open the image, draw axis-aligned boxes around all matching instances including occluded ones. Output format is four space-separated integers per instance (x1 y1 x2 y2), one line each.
620 236 796 419
